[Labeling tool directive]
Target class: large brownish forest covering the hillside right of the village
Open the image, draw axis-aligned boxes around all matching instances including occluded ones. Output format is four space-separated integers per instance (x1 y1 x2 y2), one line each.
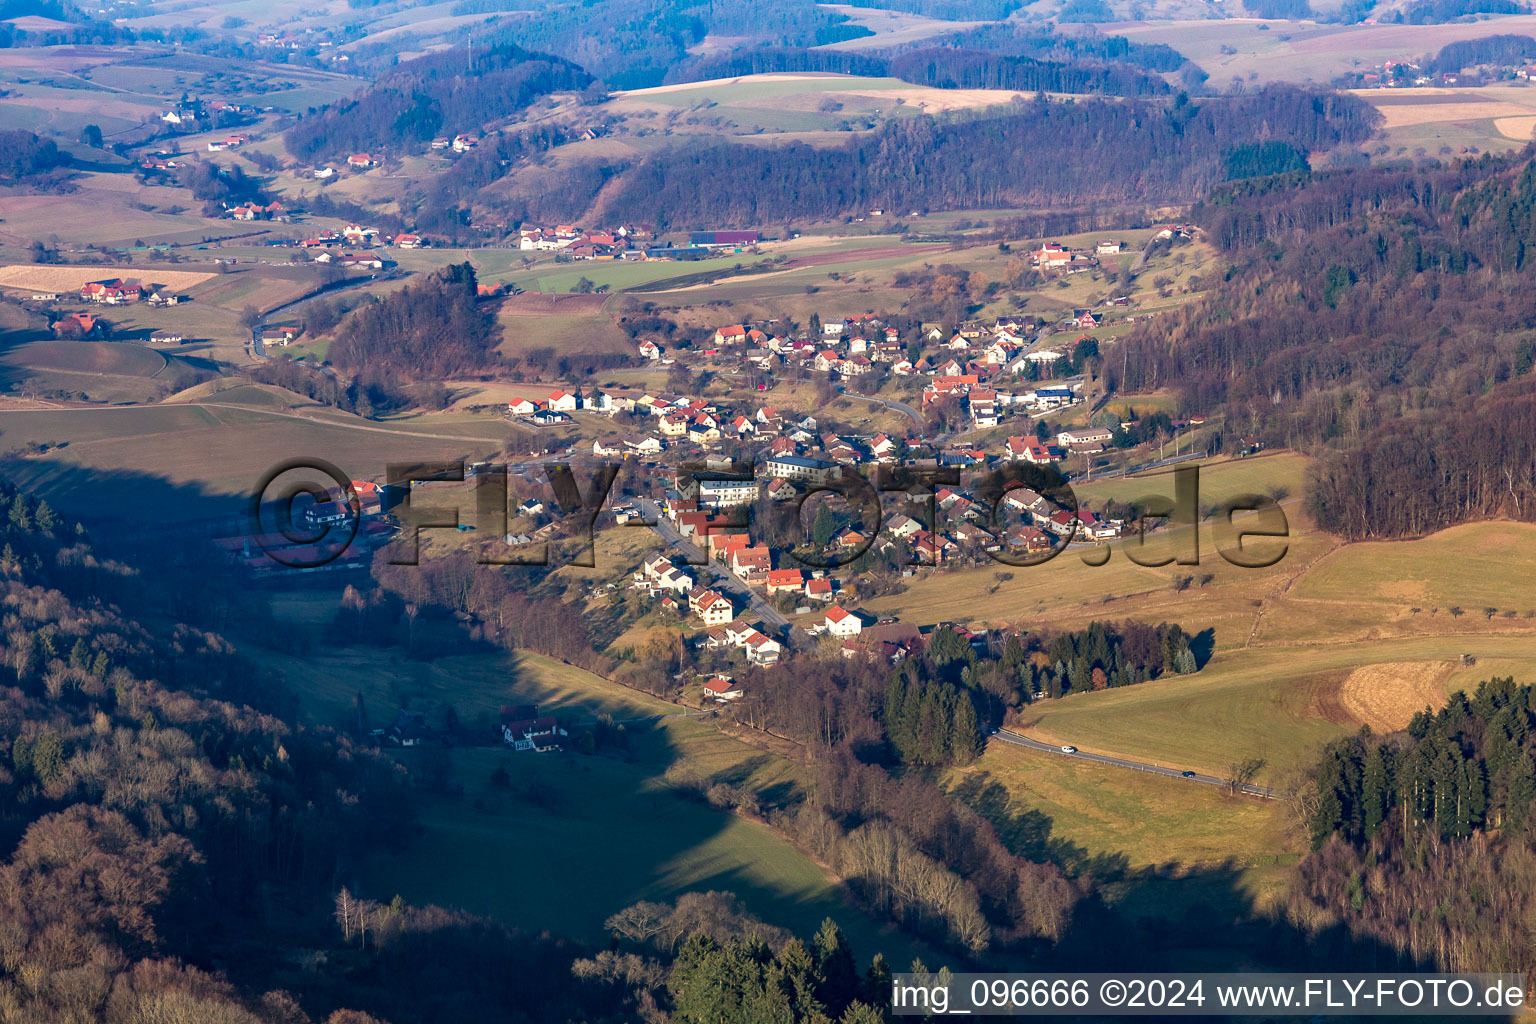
1107 150 1536 537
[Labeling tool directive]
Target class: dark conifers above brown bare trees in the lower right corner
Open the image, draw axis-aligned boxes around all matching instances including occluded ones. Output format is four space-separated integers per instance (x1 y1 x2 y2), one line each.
1289 679 1536 972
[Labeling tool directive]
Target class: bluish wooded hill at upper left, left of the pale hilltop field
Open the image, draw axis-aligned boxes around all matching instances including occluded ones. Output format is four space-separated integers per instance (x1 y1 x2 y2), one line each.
284 41 591 161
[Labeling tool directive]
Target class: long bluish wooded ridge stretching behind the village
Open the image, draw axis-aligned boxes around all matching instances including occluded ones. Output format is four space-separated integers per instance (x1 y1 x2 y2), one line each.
568 88 1378 229
